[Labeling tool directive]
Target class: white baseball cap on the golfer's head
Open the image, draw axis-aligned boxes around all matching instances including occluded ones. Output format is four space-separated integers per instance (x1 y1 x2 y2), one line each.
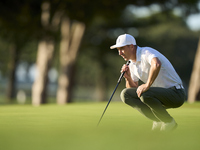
110 34 136 49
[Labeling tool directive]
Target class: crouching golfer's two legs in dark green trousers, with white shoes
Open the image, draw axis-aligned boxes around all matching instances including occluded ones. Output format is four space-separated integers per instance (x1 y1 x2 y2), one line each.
121 88 185 130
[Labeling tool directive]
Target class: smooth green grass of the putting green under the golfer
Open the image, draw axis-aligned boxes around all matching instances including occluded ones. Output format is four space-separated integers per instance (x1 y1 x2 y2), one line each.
0 102 200 150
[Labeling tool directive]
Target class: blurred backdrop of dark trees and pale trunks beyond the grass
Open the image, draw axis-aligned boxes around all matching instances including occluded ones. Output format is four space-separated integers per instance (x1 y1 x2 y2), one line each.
0 0 200 105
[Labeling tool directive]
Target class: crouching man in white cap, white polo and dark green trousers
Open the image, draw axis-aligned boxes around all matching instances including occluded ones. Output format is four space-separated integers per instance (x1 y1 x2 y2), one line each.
110 34 186 131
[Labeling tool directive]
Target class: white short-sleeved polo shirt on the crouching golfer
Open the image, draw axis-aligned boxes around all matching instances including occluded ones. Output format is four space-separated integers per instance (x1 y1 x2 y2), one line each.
129 46 182 88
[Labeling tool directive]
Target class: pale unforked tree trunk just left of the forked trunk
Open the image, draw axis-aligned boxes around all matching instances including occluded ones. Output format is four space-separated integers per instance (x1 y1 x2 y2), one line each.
32 1 55 106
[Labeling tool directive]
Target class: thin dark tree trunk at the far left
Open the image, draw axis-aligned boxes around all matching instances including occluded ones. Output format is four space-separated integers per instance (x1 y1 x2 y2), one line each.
7 44 18 101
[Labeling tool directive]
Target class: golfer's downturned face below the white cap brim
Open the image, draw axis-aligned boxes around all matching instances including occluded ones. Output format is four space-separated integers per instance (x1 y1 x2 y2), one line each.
117 45 132 61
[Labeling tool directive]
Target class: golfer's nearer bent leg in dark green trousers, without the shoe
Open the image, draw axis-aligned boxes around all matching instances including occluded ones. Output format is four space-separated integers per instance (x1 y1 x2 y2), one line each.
140 87 185 122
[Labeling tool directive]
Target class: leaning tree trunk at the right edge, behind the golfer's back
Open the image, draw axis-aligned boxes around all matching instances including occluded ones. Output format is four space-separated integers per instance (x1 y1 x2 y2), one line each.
188 39 200 103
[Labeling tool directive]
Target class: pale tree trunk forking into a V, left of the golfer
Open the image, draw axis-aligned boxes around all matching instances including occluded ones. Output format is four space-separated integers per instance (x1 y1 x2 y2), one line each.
57 17 85 104
